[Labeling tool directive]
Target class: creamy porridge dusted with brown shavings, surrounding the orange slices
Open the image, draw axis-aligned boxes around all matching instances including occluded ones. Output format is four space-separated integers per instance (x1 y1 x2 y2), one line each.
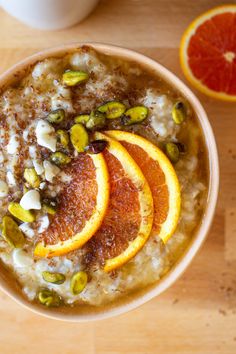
0 47 208 306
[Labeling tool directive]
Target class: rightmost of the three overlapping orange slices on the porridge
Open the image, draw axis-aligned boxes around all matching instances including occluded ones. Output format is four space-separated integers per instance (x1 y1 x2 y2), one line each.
106 130 181 242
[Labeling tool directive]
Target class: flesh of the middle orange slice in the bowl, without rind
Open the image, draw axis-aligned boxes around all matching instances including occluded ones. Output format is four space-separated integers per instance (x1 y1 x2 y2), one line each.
84 150 141 264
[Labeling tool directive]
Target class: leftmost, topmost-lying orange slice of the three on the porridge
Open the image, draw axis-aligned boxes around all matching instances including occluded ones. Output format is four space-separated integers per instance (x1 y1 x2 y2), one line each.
34 154 109 257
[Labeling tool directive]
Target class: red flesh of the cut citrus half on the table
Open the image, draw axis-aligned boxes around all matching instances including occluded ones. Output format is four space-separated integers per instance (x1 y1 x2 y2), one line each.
187 12 236 95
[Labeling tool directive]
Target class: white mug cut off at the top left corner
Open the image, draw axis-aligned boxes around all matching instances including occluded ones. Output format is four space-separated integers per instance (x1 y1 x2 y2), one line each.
0 0 99 30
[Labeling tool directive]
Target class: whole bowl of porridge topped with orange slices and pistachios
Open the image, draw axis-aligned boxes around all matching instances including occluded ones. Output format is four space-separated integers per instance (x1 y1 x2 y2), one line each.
0 43 219 322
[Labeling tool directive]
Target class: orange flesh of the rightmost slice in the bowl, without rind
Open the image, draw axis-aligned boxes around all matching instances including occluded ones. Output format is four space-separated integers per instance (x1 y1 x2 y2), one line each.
120 141 169 232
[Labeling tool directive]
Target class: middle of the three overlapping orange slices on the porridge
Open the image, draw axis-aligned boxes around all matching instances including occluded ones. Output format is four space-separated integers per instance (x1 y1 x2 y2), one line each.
85 133 153 272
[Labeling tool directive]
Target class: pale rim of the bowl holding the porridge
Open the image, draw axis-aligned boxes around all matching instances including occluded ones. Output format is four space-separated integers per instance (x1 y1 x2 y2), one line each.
0 42 219 322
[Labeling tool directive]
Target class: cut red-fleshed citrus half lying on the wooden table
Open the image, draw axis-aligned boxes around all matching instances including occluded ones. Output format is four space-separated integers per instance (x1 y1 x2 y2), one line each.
180 5 236 101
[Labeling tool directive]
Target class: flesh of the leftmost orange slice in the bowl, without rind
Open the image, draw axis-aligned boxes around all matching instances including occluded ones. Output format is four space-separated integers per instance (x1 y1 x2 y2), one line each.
40 154 97 244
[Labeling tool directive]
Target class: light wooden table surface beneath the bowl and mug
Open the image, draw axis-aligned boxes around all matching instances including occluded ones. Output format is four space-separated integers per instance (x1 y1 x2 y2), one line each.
0 0 236 354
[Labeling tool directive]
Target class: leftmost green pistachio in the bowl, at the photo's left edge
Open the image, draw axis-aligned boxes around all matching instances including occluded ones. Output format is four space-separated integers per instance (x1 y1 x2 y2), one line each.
2 216 25 248
